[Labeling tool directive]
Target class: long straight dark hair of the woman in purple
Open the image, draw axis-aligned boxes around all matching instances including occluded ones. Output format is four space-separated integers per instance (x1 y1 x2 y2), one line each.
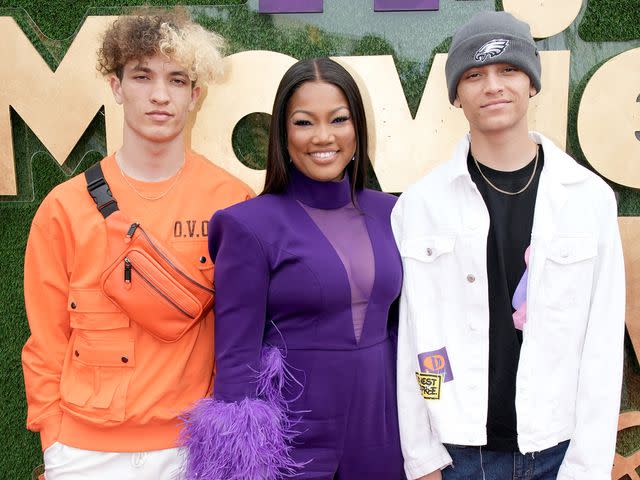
262 57 370 201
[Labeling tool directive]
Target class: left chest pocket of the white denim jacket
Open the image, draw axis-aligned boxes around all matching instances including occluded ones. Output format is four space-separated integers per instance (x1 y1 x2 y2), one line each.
400 235 456 298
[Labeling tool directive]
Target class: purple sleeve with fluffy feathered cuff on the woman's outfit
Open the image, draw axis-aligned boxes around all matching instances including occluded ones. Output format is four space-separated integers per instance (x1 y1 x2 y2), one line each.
182 211 299 480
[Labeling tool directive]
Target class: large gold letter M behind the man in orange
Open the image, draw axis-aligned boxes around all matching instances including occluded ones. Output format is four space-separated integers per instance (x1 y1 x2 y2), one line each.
0 17 114 195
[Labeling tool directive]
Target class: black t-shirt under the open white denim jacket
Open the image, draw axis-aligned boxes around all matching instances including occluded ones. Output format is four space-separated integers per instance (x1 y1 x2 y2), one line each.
467 147 544 451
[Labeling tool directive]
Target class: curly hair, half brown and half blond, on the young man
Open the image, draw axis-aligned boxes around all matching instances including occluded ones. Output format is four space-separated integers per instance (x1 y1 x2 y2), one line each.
96 7 225 83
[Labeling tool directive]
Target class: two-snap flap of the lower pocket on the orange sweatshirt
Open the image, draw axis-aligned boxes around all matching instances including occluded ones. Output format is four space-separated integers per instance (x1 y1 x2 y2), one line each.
73 335 136 368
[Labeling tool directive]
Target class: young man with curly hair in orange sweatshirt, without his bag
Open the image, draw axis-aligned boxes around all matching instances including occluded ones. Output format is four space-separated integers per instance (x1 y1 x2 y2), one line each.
22 9 252 480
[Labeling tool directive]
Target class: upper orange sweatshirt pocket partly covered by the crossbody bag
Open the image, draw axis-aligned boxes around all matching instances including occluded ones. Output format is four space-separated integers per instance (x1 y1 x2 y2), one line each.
67 287 129 330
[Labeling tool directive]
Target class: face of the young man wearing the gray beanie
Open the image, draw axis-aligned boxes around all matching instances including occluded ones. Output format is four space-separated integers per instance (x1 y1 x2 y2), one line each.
453 63 536 134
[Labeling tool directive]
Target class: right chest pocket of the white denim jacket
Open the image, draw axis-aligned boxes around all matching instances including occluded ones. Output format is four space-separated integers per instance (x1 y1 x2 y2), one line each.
541 236 598 310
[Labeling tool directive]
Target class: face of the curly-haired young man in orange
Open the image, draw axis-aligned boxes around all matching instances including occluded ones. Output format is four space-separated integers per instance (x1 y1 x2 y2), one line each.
110 54 200 143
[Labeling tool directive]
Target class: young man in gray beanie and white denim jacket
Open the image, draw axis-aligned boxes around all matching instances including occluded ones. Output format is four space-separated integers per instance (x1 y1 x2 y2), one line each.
392 12 625 480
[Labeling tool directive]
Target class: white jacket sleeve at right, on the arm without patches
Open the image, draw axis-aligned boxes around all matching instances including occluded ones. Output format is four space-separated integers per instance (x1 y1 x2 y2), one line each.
558 191 625 480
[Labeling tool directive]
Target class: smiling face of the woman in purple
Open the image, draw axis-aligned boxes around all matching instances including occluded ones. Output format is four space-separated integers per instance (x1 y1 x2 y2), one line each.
286 81 356 182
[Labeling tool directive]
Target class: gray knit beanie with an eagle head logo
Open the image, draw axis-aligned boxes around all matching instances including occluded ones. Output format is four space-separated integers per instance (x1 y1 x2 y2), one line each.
445 12 542 104
